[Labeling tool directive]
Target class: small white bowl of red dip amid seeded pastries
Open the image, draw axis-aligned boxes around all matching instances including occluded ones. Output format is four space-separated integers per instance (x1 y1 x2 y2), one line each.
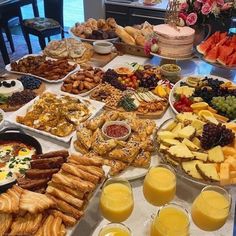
102 121 131 141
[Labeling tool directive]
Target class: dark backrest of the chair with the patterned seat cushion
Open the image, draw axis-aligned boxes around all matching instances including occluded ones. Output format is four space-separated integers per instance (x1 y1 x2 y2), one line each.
44 0 64 28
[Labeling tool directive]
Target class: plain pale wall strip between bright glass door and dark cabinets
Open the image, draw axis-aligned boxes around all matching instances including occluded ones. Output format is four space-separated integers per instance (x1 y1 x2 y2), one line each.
84 0 105 20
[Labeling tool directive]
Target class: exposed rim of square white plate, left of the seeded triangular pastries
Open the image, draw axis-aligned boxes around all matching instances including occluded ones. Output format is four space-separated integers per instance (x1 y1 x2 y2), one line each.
6 91 105 143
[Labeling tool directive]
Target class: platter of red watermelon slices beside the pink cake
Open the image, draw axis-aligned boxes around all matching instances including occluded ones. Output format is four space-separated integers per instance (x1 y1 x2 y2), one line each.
196 31 236 69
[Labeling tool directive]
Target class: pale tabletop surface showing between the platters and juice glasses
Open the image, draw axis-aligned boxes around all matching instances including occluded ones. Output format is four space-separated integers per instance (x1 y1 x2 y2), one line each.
2 55 236 236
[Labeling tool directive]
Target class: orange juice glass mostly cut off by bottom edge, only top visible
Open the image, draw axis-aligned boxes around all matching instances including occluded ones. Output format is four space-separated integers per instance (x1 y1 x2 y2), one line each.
98 223 132 236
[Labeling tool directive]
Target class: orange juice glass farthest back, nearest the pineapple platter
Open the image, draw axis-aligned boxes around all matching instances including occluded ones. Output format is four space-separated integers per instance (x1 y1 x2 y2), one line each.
143 164 176 206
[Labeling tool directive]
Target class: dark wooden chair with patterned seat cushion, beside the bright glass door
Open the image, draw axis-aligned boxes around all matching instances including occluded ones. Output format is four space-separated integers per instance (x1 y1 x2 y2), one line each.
21 0 64 53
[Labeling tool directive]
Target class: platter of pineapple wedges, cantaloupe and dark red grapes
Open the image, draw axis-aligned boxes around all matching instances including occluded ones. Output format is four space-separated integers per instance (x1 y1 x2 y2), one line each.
157 112 236 186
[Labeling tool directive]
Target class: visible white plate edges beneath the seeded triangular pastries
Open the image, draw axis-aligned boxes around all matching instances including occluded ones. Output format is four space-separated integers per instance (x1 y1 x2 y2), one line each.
69 133 159 180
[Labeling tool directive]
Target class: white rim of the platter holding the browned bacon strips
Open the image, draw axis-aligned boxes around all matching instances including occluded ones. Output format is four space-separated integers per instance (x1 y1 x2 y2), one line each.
5 54 80 83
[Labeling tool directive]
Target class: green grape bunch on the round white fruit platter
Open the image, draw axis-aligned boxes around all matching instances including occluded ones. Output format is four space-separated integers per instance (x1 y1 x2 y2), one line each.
211 96 236 120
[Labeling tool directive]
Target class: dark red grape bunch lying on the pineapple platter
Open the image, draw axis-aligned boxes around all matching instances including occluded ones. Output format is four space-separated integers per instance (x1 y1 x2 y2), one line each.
201 123 235 150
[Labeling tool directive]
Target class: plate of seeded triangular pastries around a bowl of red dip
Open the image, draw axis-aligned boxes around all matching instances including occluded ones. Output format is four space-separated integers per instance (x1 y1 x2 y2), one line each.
70 111 158 179
